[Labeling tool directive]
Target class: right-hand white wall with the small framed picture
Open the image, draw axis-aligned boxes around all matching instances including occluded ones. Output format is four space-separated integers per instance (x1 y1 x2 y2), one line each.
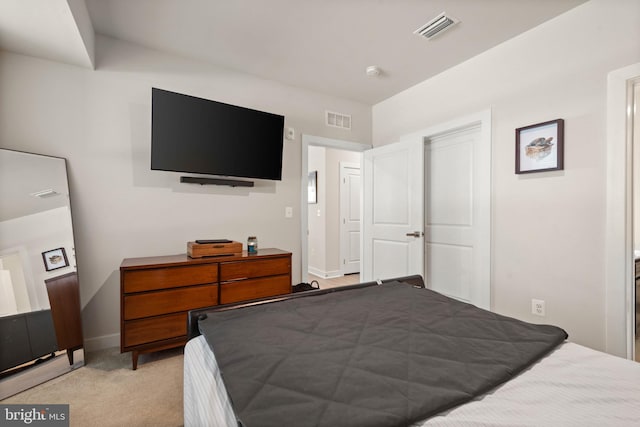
373 0 640 349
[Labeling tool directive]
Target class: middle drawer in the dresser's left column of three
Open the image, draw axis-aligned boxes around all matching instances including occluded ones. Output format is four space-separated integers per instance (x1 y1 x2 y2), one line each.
124 285 218 320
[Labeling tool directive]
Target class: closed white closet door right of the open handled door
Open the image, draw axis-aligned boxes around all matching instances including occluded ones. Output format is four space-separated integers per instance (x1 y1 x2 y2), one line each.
425 124 490 309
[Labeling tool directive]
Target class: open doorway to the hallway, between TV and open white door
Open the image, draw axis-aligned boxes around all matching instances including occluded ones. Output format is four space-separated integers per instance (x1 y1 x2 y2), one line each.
300 135 371 283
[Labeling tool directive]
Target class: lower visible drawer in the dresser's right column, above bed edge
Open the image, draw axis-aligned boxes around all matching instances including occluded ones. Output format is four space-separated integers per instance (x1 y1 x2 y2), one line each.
220 274 291 304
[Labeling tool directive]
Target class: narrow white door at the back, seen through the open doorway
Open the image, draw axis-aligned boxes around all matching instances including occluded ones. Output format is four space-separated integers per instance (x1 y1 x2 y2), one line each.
340 162 360 274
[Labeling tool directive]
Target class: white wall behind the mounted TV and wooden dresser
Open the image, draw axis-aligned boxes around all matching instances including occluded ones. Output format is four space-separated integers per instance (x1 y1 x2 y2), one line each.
0 37 371 347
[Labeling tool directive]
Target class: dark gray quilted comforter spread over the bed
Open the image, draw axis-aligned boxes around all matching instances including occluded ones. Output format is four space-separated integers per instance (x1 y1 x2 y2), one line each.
199 283 567 427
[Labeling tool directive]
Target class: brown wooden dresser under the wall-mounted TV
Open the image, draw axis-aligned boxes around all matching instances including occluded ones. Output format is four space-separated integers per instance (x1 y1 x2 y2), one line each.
120 249 291 369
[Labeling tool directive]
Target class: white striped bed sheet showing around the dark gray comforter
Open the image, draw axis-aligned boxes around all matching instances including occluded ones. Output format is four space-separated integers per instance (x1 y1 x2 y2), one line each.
184 336 640 427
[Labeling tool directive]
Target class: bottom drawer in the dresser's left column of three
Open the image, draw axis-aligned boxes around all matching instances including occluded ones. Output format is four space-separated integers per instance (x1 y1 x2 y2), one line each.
123 312 187 347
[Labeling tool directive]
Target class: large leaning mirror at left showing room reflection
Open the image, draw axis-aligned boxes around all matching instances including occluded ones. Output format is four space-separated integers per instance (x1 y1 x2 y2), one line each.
0 149 84 399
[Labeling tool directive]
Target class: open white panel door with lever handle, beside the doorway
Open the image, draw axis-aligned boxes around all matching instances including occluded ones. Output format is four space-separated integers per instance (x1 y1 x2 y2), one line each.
361 138 424 281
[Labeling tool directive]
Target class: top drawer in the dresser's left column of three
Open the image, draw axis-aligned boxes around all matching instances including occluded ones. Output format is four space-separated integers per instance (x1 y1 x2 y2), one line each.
122 264 218 293
